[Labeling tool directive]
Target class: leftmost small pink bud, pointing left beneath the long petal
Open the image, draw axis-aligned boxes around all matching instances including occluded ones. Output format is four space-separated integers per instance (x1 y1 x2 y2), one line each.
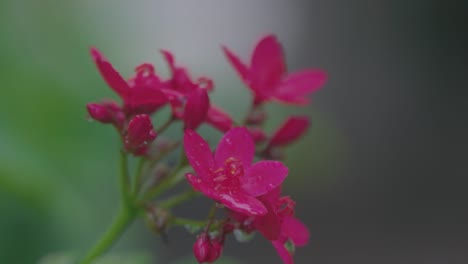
86 101 125 130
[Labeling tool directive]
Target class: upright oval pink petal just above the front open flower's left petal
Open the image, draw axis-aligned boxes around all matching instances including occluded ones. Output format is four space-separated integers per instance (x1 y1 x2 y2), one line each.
184 89 210 129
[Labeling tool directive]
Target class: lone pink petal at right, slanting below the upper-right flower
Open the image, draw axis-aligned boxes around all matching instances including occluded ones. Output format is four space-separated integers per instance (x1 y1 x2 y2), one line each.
269 116 309 146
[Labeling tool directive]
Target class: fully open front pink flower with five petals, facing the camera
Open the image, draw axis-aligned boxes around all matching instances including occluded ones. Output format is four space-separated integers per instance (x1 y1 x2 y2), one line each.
184 128 288 215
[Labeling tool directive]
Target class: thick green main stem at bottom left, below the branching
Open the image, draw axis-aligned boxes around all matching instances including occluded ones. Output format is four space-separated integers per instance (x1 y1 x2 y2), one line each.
79 208 136 264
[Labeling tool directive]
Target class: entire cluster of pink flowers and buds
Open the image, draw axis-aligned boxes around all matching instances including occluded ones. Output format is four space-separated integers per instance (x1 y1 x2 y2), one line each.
87 35 326 263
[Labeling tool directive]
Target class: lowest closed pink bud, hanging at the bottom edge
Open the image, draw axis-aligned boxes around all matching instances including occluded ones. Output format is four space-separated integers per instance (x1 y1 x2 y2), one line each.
193 233 223 263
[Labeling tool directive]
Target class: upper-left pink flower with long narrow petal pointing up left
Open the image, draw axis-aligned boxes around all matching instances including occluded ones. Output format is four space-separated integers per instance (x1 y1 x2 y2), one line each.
91 48 167 115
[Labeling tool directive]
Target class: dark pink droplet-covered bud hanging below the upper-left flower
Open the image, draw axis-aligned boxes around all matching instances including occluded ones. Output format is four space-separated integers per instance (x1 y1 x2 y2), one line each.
124 114 156 156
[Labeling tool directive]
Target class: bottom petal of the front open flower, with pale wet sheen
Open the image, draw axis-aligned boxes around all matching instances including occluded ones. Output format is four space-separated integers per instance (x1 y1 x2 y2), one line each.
218 191 268 216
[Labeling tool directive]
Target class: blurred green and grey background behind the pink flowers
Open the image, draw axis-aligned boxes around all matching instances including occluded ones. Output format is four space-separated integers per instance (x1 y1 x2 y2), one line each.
0 0 468 264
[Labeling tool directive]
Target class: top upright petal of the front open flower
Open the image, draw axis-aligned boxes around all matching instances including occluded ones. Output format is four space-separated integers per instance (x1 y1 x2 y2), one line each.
215 127 255 169
